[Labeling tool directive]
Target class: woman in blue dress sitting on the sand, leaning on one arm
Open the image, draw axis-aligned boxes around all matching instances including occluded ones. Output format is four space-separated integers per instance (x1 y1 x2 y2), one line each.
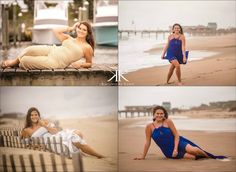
135 106 226 160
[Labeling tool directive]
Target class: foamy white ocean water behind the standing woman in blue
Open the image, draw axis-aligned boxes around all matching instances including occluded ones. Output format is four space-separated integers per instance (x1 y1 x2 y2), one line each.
119 34 217 73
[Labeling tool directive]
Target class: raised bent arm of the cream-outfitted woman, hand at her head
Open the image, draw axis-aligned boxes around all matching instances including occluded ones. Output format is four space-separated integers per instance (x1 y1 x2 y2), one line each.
53 22 79 42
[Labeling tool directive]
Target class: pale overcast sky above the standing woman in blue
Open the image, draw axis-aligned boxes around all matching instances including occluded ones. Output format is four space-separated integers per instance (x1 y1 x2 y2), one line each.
119 0 236 30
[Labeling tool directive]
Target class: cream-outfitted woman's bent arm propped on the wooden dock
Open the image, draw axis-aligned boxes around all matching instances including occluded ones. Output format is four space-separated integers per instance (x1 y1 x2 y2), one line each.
70 46 93 69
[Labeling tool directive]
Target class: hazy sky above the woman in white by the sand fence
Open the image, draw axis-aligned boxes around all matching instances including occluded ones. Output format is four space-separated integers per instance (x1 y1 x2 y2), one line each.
0 86 118 118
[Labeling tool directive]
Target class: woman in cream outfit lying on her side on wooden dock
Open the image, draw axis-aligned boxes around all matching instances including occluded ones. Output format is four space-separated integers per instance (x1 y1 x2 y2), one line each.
1 21 94 70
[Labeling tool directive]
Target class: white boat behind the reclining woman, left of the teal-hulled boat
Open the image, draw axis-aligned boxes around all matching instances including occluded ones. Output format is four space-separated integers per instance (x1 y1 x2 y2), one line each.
32 0 71 44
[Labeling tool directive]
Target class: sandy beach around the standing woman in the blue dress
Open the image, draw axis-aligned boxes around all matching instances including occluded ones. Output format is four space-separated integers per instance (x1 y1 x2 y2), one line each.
120 34 236 86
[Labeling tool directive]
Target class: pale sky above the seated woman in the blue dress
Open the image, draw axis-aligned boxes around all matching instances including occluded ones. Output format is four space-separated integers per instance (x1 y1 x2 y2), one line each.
119 86 236 110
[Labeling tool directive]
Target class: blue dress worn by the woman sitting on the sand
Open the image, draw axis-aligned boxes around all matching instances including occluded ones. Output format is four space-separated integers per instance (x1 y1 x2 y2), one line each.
152 126 227 159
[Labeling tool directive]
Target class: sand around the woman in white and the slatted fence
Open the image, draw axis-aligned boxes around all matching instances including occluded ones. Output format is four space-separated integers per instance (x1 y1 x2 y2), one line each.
0 115 118 172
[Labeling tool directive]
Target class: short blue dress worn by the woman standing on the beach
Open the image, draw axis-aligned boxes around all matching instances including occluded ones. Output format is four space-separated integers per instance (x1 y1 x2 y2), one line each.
165 38 189 64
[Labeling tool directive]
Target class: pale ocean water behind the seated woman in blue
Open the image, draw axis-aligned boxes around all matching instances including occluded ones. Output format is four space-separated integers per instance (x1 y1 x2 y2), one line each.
129 117 236 132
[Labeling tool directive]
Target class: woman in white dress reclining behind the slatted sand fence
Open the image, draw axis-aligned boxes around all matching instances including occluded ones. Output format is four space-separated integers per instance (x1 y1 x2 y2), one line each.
21 107 105 158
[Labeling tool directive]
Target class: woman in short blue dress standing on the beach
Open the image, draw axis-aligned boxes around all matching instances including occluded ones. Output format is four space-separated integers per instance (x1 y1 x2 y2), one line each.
161 23 187 85
